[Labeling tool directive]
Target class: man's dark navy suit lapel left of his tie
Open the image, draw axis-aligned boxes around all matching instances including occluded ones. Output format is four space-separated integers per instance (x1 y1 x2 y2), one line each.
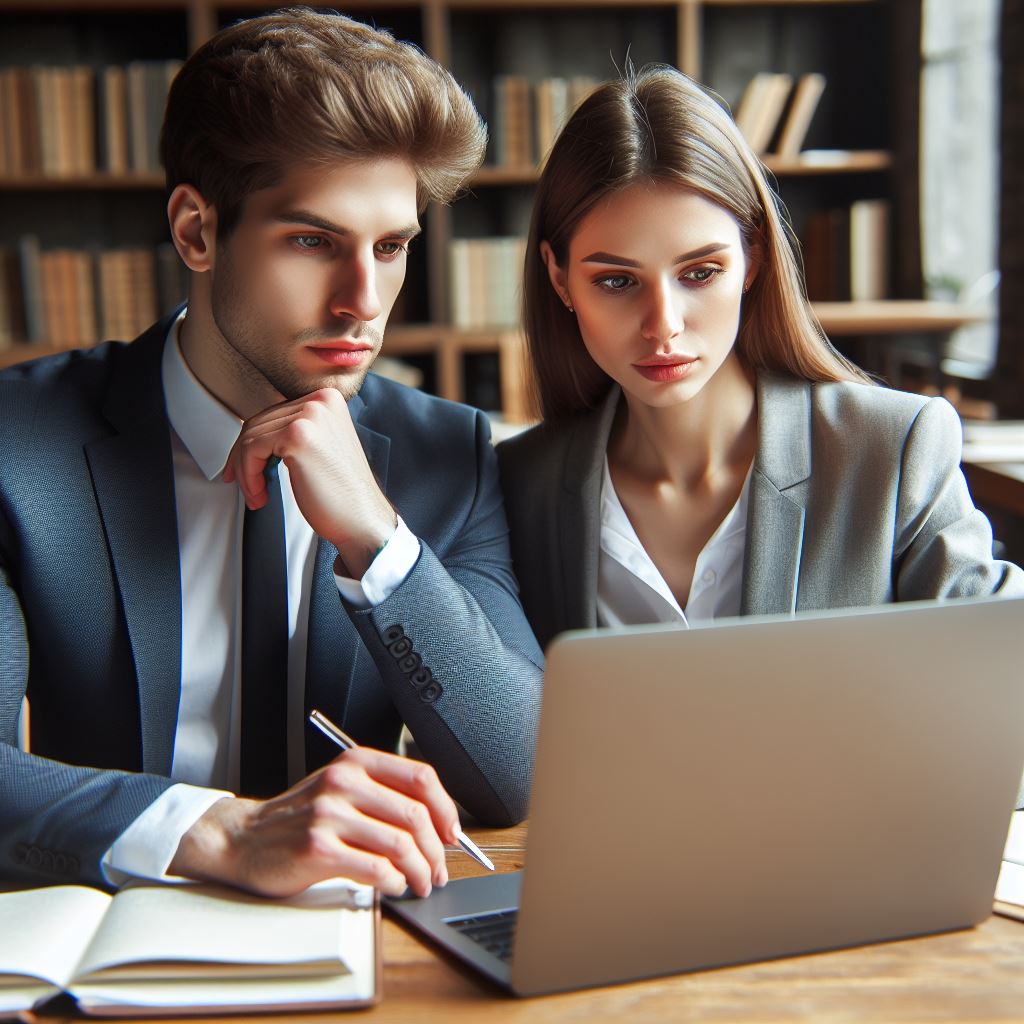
85 321 181 775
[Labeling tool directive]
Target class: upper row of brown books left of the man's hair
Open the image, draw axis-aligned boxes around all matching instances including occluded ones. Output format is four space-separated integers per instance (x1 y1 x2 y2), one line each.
0 60 181 177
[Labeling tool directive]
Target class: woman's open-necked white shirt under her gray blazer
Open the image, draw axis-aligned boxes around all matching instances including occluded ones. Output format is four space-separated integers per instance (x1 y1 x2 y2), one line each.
597 456 751 626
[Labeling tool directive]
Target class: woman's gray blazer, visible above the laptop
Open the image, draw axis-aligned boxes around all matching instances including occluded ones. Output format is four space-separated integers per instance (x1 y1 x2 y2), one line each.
498 375 1024 645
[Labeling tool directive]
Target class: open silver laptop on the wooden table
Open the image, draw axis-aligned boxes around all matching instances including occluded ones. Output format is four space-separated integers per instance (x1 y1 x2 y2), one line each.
389 599 1024 995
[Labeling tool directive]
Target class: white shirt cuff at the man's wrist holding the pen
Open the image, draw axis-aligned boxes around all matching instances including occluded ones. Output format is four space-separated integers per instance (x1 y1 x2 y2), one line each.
99 782 233 887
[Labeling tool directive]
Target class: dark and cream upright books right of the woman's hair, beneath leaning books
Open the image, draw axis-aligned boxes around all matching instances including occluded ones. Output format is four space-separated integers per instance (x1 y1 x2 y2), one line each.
802 199 891 302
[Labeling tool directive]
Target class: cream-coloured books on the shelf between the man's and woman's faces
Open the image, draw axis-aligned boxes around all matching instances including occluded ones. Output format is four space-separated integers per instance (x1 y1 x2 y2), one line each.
449 238 526 329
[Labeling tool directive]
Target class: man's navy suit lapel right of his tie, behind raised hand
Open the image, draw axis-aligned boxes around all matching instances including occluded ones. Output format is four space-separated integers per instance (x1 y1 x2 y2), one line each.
304 378 391 771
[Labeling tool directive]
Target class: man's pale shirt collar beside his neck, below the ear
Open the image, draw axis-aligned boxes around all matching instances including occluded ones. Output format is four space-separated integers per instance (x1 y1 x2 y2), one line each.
163 309 243 480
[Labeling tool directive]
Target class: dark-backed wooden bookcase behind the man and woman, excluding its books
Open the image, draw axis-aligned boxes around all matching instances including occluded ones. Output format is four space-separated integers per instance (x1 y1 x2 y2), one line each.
0 0 925 415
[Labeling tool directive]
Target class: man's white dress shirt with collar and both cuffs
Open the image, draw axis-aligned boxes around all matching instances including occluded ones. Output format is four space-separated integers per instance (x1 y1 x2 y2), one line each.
102 313 420 885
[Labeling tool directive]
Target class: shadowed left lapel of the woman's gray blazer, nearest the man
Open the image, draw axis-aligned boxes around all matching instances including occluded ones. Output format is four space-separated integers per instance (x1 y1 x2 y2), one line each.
558 386 621 629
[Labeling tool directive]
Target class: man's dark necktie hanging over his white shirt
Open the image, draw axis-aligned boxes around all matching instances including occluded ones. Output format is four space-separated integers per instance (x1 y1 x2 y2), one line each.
241 460 288 797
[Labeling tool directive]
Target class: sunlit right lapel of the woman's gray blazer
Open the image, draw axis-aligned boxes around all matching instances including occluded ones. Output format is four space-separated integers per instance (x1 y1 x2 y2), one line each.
740 374 811 615
